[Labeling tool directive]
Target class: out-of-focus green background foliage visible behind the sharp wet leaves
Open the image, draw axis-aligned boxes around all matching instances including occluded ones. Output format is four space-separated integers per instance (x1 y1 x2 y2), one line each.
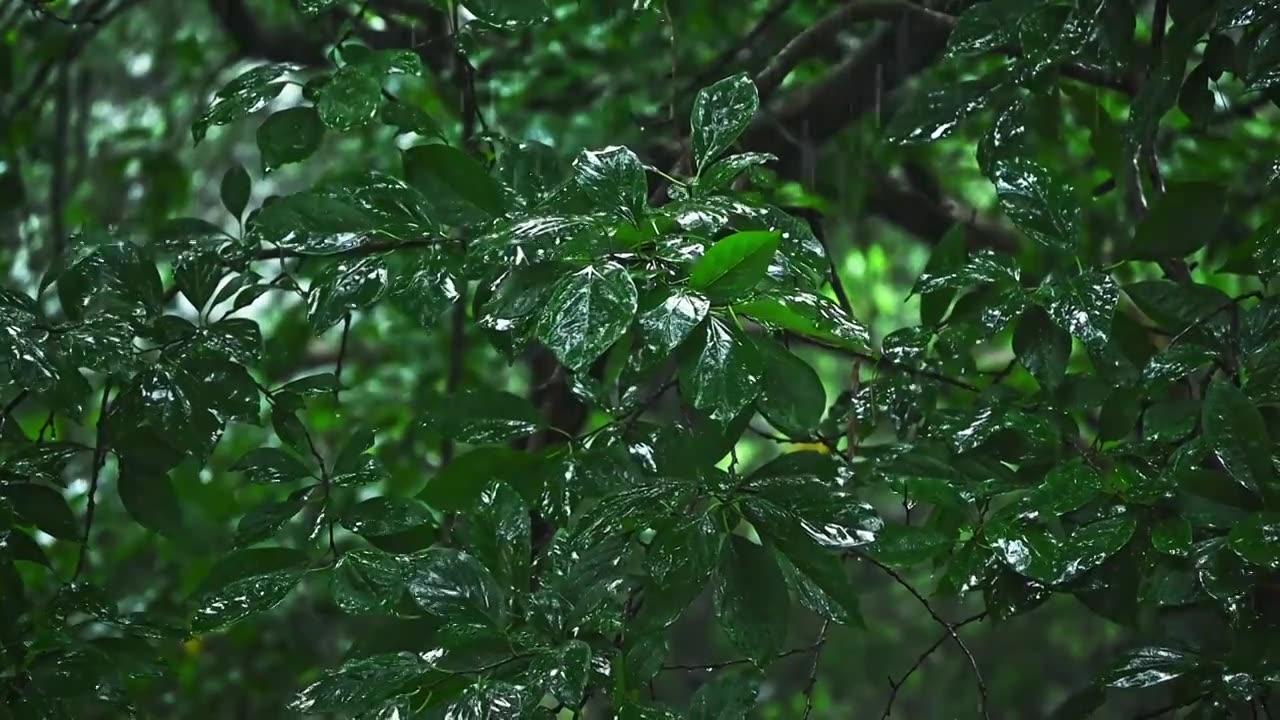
0 0 1280 720
